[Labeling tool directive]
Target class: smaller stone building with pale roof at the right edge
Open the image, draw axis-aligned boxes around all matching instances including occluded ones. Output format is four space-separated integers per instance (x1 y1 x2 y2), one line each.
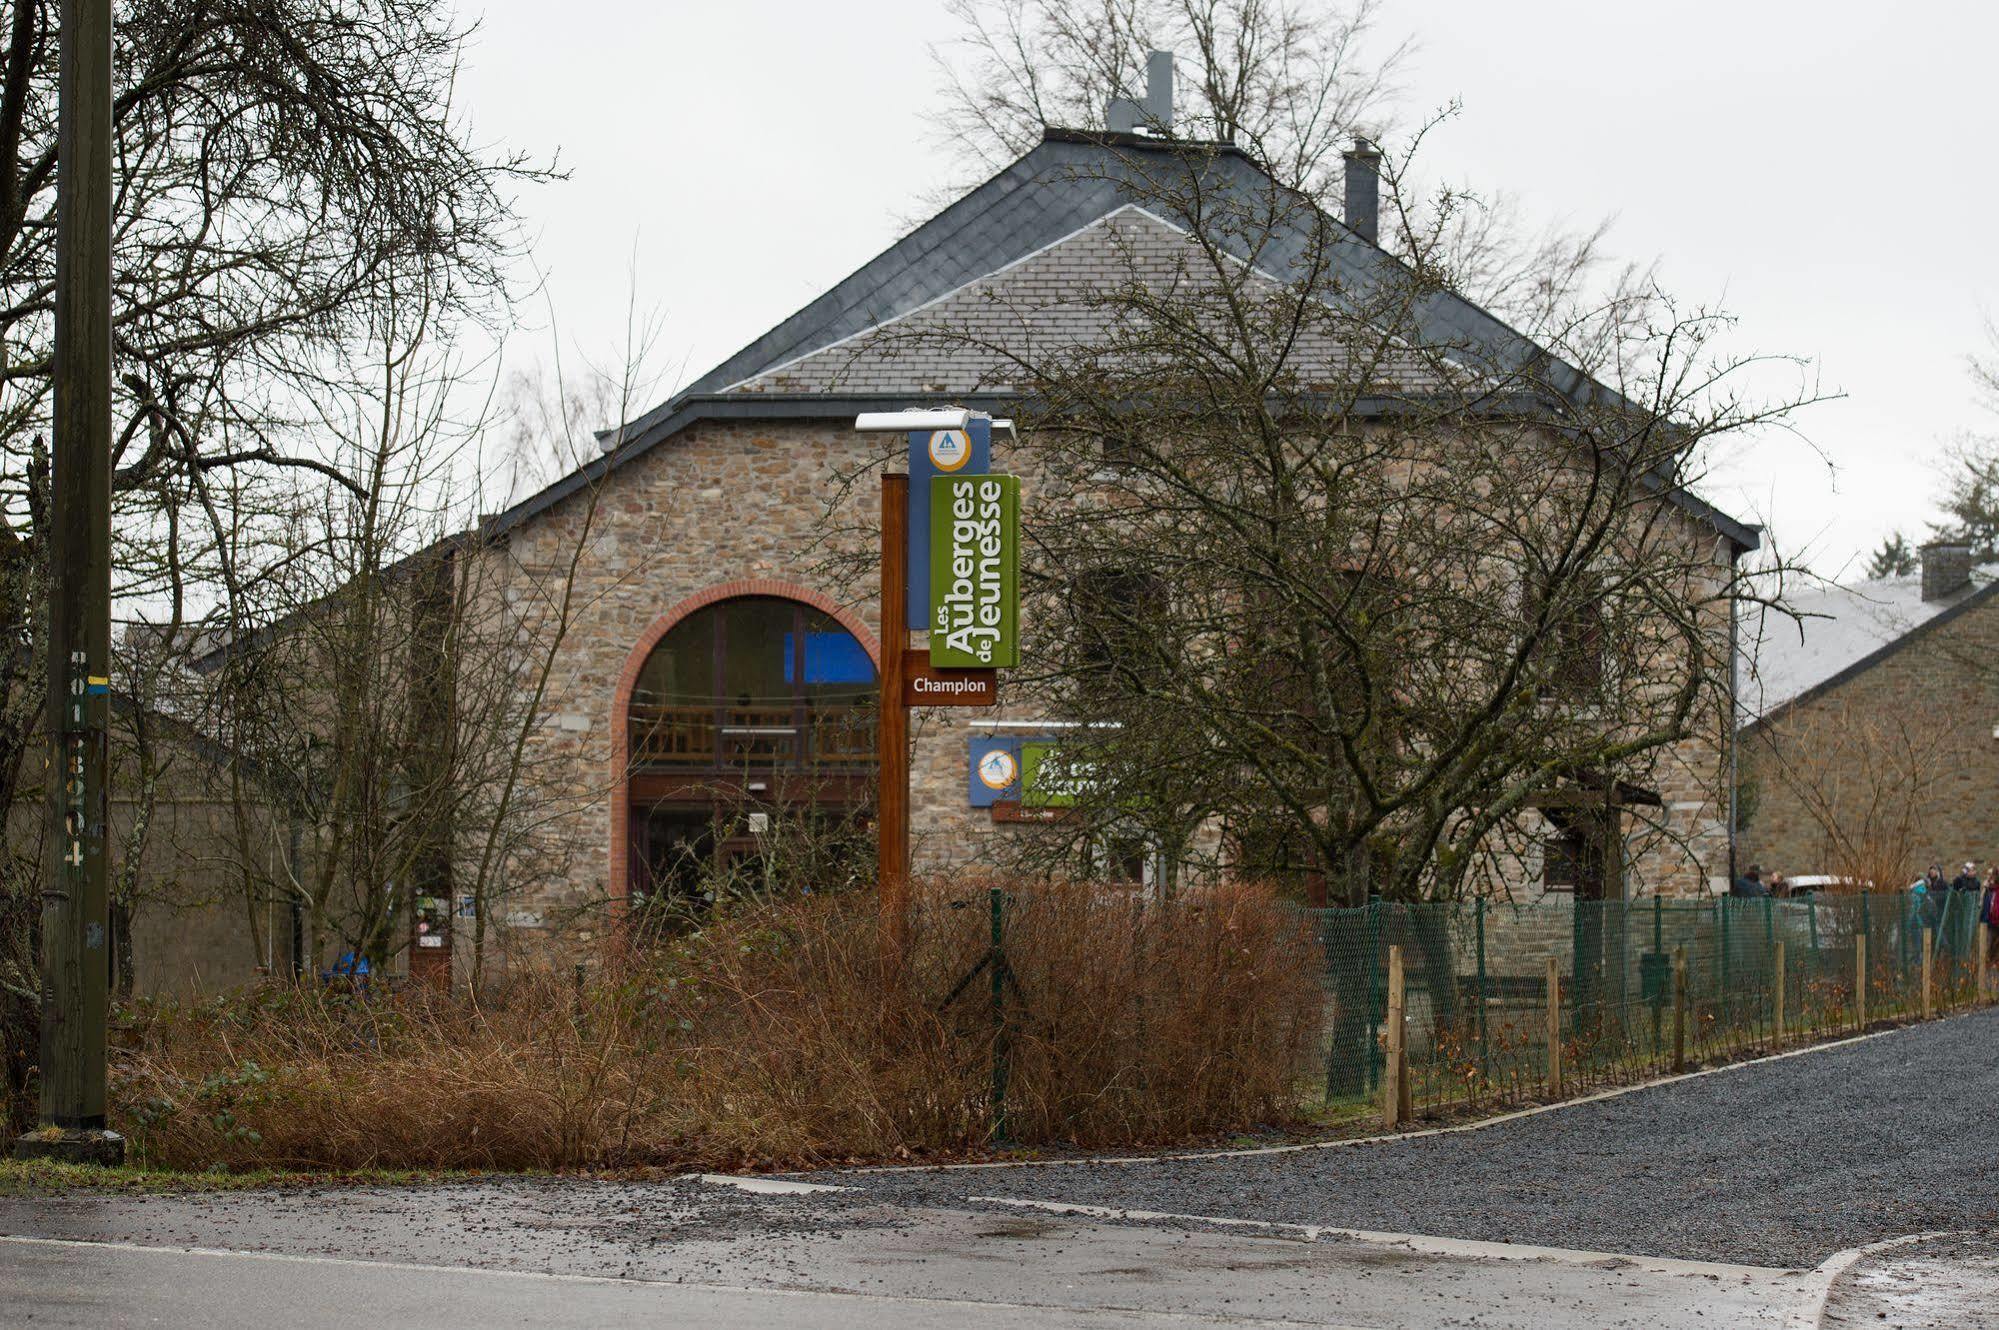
1737 542 1999 890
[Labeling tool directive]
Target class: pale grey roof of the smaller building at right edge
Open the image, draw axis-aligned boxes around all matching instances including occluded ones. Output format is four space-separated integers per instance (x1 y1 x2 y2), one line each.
1735 568 1999 726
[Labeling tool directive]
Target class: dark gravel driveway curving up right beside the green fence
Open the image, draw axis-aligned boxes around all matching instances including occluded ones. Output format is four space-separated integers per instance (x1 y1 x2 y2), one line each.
818 1008 1999 1268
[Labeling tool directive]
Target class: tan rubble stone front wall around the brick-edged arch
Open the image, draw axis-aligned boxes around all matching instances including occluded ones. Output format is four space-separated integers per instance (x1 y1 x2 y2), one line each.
476 408 1727 944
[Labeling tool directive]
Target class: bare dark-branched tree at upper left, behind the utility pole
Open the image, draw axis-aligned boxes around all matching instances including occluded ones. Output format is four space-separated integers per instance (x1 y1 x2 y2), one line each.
0 0 546 1096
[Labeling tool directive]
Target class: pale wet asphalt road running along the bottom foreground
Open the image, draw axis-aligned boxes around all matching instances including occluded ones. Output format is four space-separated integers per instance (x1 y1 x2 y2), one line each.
0 1216 1809 1330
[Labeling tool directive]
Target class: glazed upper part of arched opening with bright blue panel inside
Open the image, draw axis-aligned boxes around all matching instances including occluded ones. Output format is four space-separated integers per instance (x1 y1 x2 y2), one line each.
632 596 876 772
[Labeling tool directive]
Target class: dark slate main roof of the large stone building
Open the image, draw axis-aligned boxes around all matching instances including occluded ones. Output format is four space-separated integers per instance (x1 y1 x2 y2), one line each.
484 116 1757 550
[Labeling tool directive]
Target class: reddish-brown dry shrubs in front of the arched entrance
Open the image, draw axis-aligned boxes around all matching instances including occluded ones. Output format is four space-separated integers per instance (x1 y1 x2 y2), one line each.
114 884 1319 1170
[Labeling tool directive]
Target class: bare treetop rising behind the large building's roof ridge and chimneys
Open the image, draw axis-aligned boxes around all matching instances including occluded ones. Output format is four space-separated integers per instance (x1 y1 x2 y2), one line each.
934 0 1653 336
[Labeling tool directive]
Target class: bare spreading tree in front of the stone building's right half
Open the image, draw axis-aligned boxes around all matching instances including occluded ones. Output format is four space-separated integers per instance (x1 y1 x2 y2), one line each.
854 130 1809 900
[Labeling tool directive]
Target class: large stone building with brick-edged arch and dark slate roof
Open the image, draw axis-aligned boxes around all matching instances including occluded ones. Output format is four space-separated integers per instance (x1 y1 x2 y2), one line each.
445 130 1757 964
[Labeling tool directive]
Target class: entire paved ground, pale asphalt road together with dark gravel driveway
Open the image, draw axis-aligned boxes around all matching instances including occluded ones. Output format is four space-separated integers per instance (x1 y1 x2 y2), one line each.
0 1012 1999 1330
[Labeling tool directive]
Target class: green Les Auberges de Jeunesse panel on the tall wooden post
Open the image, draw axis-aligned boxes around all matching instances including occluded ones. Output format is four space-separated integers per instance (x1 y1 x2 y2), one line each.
930 476 1019 670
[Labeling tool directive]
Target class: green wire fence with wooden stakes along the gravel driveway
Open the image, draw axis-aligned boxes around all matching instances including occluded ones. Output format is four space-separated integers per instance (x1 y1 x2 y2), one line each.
1307 892 1987 1110
